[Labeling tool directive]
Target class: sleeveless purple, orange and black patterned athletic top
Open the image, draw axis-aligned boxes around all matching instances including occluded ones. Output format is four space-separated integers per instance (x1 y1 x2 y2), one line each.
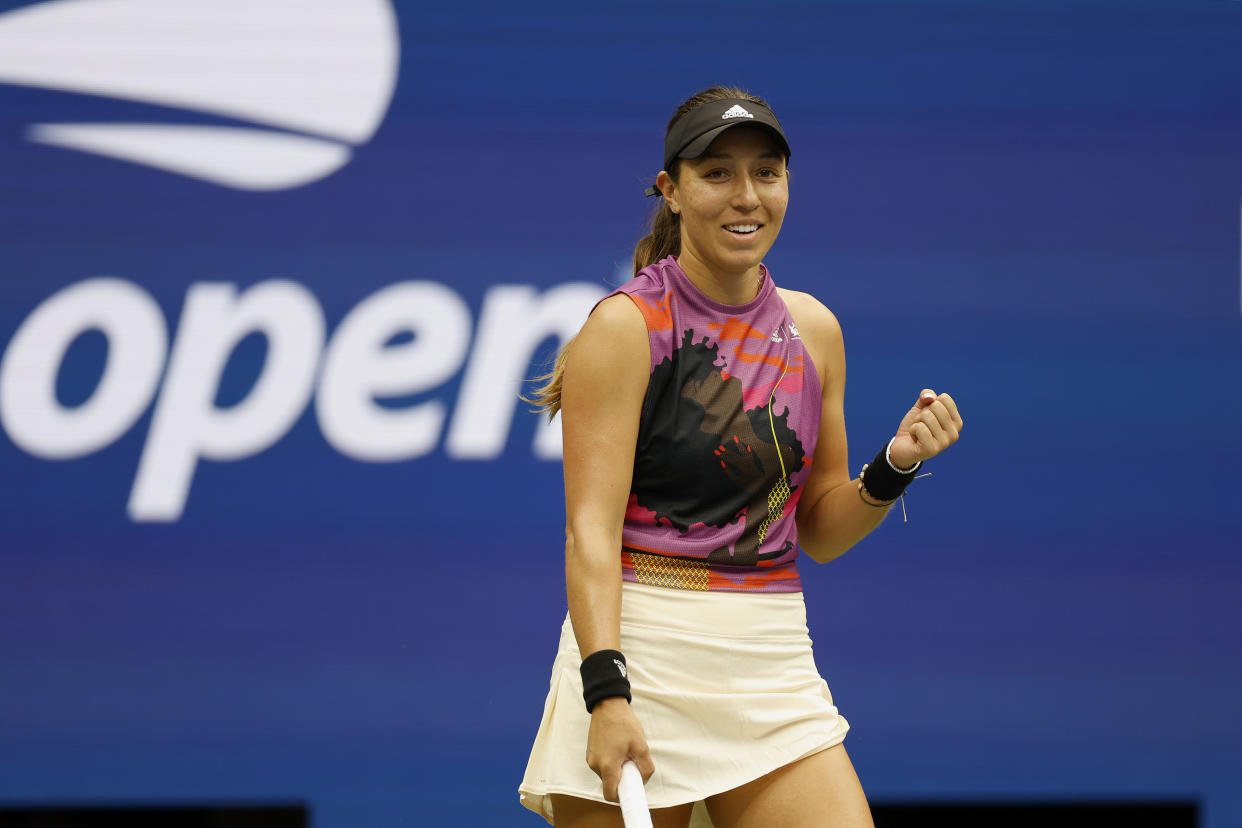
614 256 821 592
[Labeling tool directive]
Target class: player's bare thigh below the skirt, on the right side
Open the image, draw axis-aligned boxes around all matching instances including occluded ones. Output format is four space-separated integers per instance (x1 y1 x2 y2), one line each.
707 745 873 828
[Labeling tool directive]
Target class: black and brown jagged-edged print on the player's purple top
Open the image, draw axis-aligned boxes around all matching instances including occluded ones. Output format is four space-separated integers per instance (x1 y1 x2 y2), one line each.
632 330 805 566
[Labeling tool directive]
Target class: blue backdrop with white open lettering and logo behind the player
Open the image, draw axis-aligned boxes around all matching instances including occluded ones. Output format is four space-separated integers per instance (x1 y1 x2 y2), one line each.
0 0 1242 828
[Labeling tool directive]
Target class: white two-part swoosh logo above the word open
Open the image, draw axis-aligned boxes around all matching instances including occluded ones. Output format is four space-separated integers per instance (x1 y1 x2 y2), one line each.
0 0 400 190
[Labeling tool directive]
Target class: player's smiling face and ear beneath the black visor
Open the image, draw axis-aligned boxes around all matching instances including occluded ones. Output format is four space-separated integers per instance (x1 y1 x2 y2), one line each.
657 125 789 295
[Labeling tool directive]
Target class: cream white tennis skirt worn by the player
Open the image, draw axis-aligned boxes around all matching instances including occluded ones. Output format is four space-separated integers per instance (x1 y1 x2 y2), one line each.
518 582 850 826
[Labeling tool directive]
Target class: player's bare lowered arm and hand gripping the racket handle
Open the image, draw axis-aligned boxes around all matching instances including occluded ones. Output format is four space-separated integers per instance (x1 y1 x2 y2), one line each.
560 294 655 802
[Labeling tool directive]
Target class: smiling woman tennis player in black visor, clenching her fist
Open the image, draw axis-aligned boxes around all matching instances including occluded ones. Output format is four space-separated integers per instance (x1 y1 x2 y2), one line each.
520 87 963 828
